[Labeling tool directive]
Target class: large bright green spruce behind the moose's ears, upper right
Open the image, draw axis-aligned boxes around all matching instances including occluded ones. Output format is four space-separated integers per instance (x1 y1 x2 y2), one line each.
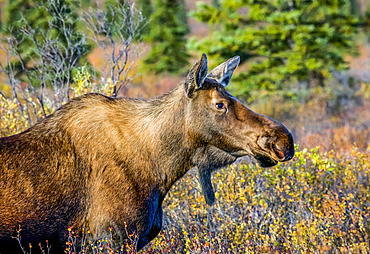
192 0 357 97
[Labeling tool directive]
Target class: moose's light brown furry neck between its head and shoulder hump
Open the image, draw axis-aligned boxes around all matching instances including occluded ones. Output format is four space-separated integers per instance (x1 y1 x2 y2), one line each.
121 85 195 198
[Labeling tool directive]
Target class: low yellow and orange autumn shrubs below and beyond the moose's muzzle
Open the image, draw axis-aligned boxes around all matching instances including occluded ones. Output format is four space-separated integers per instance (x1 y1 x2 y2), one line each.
144 147 370 253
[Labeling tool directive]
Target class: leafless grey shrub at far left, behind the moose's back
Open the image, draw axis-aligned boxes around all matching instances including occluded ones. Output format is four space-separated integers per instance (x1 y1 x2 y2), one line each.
0 0 86 125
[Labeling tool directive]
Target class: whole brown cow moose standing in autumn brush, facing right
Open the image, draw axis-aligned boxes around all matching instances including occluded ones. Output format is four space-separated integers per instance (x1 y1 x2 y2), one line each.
0 54 294 254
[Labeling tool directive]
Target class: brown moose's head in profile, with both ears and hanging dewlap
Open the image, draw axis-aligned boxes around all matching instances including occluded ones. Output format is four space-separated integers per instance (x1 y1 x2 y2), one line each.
185 54 294 205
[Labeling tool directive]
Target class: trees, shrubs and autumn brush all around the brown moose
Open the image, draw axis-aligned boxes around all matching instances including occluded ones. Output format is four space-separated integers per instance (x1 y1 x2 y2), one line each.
0 0 370 253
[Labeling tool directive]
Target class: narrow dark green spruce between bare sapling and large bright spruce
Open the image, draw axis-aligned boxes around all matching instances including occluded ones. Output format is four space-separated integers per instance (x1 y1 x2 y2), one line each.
144 0 189 73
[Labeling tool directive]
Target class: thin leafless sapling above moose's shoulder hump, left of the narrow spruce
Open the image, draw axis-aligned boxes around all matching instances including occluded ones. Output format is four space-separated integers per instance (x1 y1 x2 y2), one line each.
84 0 146 97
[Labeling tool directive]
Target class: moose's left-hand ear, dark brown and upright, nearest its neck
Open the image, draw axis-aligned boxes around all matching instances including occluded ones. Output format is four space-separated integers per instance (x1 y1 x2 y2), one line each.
184 54 208 98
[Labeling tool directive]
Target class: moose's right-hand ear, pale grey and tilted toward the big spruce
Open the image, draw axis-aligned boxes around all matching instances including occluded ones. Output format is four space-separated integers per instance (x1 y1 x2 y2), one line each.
207 56 240 87
